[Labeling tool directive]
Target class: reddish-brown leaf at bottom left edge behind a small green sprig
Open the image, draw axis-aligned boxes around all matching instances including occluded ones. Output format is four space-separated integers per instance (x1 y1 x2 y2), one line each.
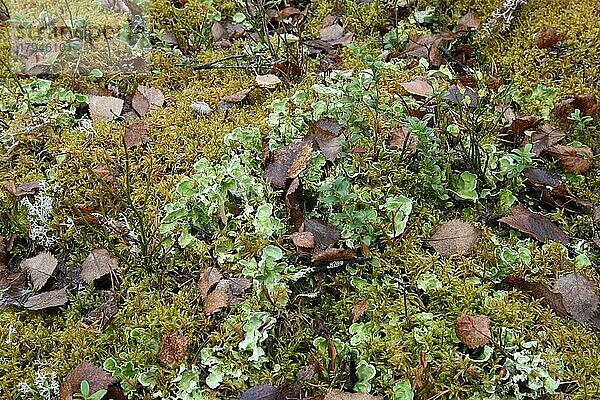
60 361 126 400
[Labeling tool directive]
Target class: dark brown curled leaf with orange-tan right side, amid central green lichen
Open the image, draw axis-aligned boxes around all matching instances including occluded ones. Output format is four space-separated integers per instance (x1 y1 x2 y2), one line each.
265 140 313 189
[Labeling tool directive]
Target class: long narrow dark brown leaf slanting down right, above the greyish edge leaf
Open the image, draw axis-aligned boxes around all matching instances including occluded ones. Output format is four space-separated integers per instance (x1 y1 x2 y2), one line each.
499 205 571 246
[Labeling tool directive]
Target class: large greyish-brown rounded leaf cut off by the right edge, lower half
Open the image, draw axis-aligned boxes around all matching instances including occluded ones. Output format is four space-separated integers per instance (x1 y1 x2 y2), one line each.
552 272 600 327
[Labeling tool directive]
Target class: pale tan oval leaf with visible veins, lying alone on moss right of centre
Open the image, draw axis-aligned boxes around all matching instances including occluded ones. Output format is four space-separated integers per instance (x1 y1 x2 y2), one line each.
428 219 481 256
